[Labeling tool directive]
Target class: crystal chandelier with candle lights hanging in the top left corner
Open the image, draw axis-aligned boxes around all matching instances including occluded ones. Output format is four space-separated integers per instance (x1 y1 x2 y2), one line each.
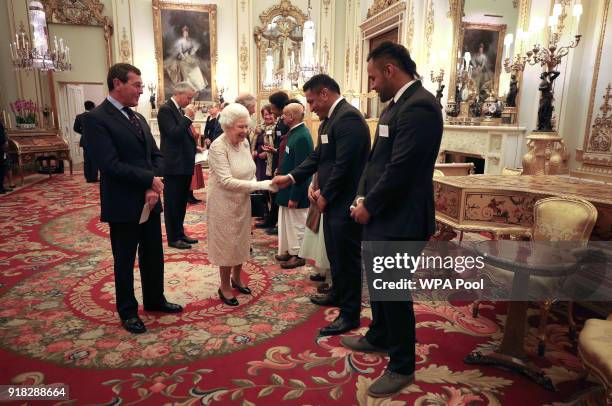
9 1 72 71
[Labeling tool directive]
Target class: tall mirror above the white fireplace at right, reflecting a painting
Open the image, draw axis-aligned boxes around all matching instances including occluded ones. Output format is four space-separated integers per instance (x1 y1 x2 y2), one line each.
446 0 530 125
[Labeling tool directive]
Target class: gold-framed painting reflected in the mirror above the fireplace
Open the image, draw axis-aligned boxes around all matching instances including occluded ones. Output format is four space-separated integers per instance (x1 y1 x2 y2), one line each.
459 22 506 95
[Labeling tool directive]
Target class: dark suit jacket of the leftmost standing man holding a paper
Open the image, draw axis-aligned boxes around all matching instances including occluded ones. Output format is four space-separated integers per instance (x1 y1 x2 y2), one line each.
83 100 163 224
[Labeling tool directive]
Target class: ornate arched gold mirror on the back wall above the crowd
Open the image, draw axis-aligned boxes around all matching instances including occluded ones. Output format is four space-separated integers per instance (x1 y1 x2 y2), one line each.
254 0 308 93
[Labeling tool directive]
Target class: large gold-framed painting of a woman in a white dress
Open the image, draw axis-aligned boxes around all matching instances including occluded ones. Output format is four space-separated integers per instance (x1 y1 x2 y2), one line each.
153 0 217 102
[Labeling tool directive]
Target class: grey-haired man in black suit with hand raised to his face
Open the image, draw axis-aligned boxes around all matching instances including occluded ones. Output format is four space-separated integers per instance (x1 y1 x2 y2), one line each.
157 82 198 249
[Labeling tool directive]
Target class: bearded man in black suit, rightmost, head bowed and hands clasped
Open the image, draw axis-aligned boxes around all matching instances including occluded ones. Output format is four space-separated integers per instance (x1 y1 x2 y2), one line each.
342 42 443 397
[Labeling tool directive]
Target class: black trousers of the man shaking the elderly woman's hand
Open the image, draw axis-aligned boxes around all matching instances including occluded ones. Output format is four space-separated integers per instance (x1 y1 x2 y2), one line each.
323 213 362 322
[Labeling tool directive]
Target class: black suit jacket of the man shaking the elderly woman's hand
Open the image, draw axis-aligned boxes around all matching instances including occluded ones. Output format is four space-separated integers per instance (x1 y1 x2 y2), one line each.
291 100 370 217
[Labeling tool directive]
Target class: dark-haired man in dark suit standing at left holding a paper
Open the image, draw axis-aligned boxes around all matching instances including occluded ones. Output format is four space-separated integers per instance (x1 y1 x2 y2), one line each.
83 63 183 334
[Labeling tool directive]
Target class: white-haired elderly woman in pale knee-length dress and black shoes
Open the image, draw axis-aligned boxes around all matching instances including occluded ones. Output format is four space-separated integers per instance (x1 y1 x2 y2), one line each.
207 103 276 306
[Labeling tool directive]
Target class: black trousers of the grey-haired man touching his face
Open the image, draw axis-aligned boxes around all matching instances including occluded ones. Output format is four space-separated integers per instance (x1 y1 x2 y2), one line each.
164 175 192 242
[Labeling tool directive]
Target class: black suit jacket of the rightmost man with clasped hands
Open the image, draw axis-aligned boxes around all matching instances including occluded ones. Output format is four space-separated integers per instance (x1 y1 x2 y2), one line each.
357 81 443 240
